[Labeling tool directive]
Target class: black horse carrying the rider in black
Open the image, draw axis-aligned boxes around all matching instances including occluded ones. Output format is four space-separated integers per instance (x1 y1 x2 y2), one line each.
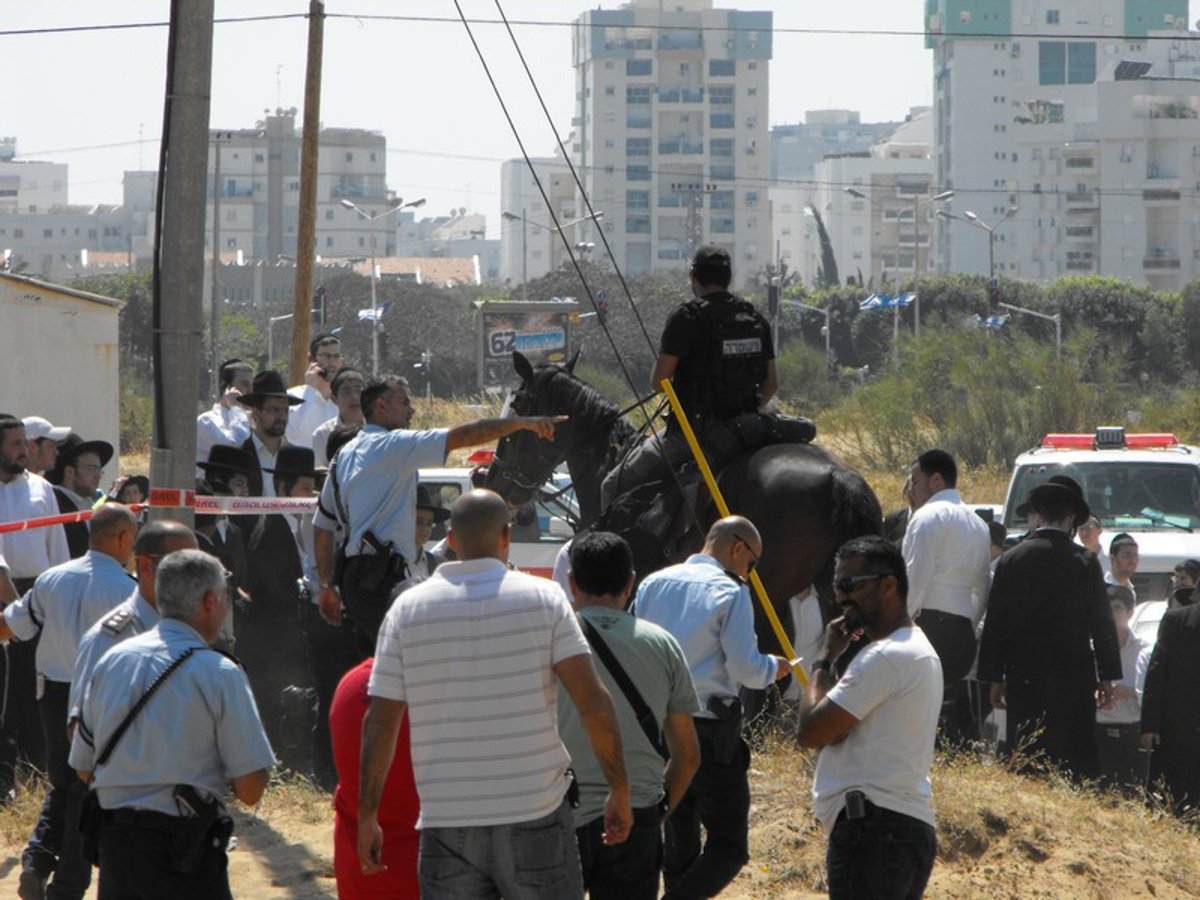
486 353 883 653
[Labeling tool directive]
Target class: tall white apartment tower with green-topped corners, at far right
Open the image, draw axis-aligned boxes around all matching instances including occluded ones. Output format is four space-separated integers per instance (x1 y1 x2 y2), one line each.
926 0 1200 283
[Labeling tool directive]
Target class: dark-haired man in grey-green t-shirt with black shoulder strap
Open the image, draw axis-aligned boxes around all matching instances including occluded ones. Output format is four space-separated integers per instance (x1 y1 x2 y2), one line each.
558 532 700 900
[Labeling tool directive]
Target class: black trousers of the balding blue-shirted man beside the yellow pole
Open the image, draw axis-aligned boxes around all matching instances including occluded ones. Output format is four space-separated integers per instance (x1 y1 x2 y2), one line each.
662 719 750 900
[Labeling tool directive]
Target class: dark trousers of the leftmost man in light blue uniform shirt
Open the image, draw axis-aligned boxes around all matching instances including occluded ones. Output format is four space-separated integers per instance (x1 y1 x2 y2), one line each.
20 682 91 900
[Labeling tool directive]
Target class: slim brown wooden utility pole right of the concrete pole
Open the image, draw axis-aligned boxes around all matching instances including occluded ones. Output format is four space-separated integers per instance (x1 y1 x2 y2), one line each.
289 0 325 384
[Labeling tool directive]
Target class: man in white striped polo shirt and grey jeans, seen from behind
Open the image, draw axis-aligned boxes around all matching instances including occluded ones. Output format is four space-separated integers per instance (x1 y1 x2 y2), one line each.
359 491 632 900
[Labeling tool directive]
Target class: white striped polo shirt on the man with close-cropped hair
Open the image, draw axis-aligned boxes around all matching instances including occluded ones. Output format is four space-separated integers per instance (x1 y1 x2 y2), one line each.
367 559 590 828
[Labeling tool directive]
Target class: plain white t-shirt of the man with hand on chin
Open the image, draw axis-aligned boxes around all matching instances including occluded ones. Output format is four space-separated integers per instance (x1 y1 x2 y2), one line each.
812 625 942 830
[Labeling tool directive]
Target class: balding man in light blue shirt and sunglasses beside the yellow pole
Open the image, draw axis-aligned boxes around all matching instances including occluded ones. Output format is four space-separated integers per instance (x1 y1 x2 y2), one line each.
634 516 792 900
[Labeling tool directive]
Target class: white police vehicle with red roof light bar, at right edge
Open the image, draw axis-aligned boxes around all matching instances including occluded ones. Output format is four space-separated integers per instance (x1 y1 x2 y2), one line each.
1003 427 1200 619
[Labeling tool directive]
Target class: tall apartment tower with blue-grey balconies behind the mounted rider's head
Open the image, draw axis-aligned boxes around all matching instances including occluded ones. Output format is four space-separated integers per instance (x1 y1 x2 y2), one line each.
571 0 773 283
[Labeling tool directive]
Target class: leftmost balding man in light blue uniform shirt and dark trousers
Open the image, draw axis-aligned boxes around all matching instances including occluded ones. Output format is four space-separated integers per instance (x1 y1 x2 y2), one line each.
0 503 138 898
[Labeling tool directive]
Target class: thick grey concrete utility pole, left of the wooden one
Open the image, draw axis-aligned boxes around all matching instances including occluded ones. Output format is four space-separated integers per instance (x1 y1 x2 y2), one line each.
150 0 214 524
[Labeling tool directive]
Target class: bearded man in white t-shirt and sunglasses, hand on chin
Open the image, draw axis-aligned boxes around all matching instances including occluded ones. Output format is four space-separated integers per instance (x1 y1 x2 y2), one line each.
798 536 942 900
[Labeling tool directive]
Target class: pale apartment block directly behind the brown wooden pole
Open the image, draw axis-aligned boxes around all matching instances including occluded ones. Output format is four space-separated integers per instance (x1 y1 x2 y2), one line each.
205 109 391 262
